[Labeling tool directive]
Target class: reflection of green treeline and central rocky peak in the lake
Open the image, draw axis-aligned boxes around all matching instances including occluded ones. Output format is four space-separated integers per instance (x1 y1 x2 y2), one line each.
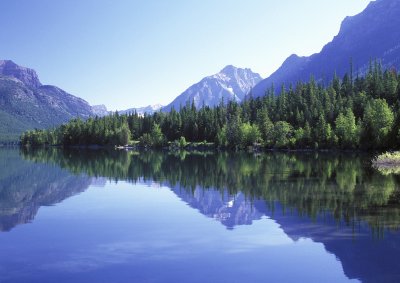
21 149 400 234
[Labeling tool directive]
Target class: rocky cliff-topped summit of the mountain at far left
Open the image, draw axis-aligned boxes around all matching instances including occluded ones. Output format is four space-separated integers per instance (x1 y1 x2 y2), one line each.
0 60 42 88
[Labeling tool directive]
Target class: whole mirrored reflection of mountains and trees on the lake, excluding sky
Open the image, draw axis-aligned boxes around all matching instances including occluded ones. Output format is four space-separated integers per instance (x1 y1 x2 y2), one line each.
0 149 400 282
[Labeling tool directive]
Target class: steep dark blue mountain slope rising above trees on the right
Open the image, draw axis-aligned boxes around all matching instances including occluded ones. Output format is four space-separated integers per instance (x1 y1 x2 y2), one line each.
252 0 400 97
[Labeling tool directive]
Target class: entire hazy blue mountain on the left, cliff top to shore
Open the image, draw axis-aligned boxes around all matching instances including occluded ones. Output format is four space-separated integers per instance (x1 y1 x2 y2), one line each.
0 60 93 142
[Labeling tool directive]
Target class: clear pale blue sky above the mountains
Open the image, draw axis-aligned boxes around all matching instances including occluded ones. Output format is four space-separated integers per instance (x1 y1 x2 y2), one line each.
0 0 370 110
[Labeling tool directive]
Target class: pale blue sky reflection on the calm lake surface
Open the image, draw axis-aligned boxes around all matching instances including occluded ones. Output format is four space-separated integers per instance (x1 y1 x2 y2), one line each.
0 182 360 283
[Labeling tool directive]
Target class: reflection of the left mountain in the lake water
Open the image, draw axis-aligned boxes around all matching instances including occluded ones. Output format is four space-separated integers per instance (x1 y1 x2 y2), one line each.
0 149 92 231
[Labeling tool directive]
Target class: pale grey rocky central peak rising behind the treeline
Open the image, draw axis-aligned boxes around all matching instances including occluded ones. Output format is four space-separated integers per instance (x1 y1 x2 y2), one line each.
163 65 262 111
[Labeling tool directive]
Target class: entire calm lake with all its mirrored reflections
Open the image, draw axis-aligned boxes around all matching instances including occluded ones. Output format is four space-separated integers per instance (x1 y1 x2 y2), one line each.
0 148 400 283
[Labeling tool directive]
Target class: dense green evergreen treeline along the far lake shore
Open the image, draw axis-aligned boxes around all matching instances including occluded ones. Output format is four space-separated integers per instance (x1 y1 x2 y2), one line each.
21 63 400 149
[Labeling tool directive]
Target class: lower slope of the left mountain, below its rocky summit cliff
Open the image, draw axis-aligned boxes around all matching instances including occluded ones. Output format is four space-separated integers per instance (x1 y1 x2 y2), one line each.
0 76 90 143
